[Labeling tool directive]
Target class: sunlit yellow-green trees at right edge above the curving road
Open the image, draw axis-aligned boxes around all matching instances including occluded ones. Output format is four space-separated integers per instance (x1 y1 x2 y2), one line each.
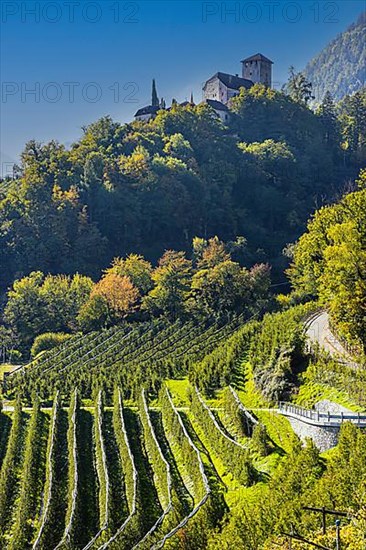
288 170 366 350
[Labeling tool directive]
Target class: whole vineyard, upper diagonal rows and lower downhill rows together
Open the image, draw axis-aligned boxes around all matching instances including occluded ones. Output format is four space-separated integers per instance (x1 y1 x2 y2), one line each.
0 317 274 550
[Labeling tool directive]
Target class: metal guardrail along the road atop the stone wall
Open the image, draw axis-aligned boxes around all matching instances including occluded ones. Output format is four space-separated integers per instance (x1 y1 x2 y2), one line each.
278 401 366 428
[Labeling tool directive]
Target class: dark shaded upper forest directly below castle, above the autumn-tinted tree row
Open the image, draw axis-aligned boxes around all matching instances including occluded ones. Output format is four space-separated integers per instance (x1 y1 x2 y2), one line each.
0 85 366 298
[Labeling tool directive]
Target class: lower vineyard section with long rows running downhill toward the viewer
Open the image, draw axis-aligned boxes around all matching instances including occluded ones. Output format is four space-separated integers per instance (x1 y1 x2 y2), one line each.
0 382 278 550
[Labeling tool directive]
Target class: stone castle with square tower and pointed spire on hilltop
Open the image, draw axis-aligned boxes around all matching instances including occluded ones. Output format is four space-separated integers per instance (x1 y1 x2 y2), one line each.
135 53 273 122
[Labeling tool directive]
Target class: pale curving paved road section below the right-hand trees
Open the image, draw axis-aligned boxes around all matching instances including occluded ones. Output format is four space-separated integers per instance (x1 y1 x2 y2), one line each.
306 311 357 366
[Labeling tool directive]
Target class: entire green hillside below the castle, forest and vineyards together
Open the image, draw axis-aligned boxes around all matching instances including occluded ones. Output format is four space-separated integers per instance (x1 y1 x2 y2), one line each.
0 43 366 550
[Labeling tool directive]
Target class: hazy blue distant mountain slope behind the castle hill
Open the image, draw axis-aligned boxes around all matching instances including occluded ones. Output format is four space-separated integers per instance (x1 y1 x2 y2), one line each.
304 12 366 103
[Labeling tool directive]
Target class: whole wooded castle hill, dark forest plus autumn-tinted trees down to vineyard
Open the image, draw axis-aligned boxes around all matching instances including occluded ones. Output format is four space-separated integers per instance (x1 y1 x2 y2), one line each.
0 85 366 360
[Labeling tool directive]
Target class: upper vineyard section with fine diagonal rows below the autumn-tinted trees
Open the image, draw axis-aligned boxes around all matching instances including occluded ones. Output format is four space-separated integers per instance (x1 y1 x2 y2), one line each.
6 316 246 399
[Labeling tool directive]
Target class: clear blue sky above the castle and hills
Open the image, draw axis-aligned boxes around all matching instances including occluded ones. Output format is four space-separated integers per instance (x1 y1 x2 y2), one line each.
0 0 365 173
